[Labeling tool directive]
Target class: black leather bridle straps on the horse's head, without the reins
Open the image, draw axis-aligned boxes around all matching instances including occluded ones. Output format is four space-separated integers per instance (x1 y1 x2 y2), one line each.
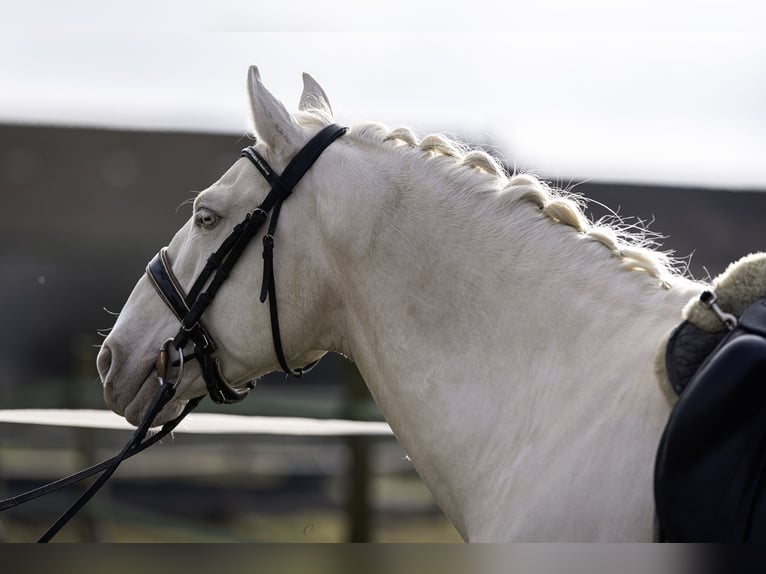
146 124 347 403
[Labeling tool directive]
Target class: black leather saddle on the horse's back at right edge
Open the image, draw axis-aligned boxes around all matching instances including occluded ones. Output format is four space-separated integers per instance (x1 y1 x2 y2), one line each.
654 299 766 542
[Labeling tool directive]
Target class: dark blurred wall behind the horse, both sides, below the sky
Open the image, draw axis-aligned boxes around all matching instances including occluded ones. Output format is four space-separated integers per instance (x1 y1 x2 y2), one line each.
0 125 766 388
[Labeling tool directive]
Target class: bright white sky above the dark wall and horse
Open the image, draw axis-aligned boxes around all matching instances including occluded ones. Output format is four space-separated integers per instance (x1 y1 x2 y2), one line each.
0 0 766 189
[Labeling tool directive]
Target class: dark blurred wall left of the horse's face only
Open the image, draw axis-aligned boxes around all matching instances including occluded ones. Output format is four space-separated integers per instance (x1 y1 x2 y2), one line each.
0 126 247 384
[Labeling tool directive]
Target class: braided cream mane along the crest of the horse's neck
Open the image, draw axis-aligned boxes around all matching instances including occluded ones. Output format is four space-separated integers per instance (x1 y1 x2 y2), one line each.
349 123 680 288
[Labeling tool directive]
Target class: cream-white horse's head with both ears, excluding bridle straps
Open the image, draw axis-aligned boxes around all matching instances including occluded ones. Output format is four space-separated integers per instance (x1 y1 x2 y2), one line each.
97 67 352 424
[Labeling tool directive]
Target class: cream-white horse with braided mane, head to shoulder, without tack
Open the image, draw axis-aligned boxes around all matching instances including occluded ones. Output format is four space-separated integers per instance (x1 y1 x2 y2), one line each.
98 67 703 541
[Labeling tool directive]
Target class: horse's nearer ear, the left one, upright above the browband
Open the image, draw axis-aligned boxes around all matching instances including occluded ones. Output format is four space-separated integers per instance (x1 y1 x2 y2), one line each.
247 66 303 154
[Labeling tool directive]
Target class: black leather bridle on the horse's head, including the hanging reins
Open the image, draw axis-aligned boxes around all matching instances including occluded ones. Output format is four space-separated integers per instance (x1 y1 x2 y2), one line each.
0 124 347 542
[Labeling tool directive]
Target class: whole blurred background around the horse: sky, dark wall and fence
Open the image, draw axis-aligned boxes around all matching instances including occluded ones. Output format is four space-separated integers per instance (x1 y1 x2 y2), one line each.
0 0 766 542
